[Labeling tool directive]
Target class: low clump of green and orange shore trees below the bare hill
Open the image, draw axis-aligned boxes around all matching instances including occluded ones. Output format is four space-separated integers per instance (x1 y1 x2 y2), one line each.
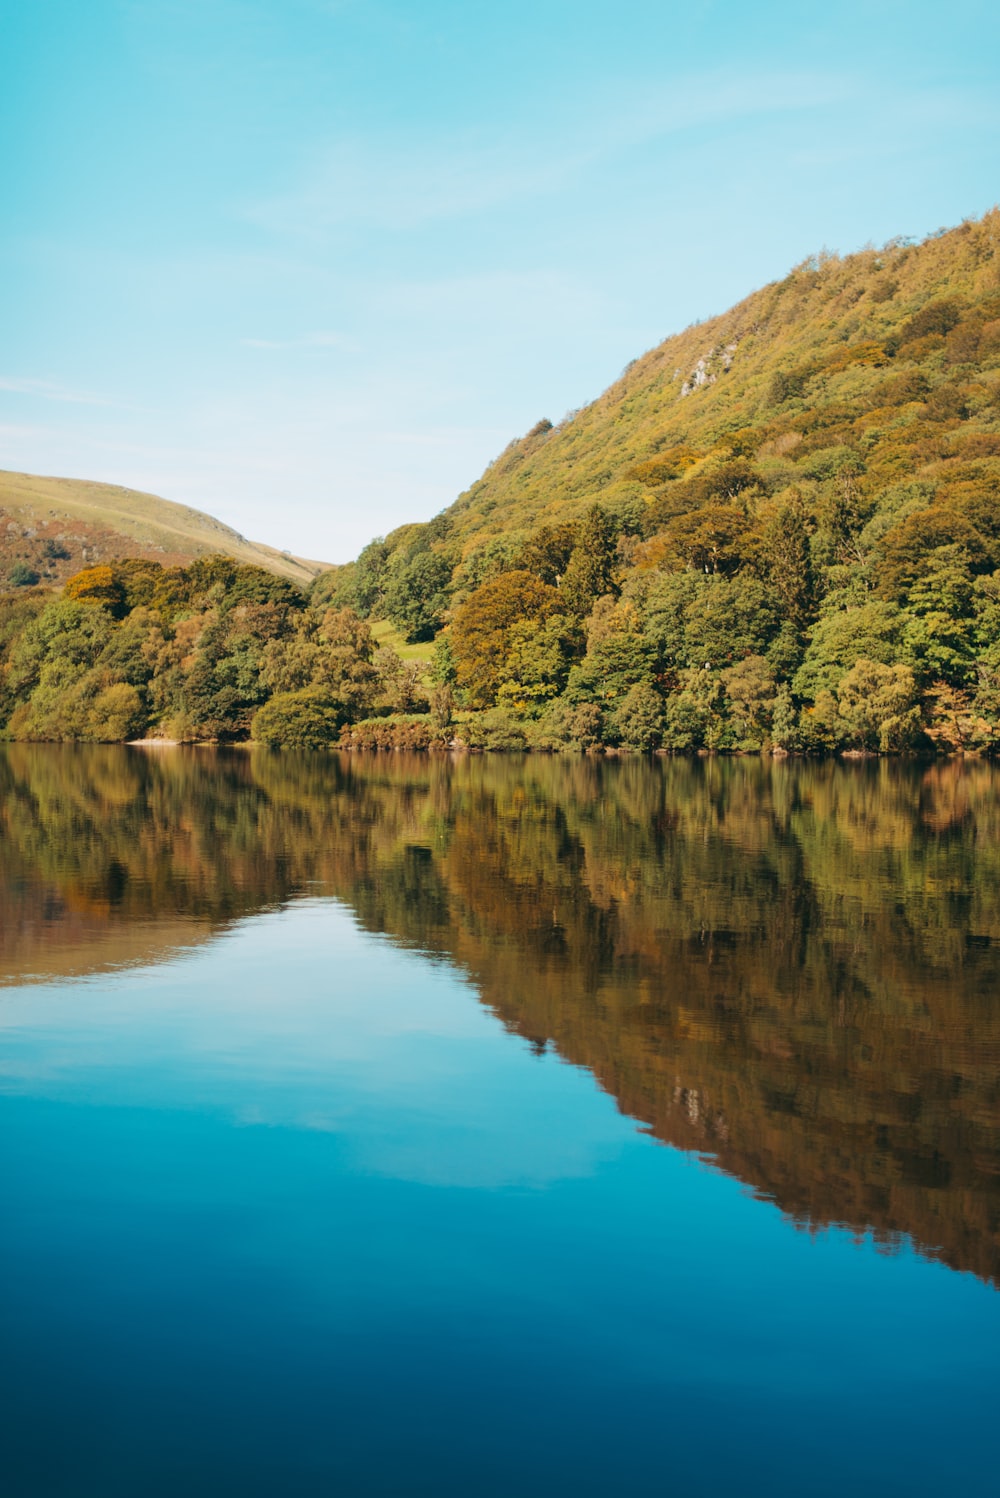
0 556 448 749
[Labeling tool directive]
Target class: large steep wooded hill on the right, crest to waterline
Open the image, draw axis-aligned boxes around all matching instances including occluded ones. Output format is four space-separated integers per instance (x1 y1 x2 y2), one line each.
320 210 1000 749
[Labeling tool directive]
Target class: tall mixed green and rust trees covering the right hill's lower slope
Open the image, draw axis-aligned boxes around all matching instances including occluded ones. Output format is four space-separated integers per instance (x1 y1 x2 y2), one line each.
321 467 1000 752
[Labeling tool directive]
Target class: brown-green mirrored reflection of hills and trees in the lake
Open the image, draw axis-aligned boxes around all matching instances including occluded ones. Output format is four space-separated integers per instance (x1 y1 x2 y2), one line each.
0 745 1000 1281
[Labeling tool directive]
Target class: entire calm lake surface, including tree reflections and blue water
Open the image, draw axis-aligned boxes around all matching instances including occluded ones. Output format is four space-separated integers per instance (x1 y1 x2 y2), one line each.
0 746 1000 1498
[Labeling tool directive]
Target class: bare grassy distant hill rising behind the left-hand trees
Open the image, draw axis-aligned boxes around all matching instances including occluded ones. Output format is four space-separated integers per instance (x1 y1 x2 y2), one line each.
0 472 326 587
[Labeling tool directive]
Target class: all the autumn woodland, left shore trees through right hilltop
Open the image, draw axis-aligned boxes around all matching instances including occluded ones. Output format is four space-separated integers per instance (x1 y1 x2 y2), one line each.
0 211 1000 753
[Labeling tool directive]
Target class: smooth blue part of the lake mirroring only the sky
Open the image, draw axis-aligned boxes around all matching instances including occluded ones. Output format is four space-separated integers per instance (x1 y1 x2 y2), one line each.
0 754 1000 1498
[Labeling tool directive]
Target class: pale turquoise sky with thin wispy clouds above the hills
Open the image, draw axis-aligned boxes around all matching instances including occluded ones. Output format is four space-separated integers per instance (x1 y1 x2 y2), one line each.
0 0 1000 560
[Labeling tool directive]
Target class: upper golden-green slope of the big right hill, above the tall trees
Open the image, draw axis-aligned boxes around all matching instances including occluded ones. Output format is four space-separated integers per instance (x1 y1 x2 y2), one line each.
434 211 1000 556
